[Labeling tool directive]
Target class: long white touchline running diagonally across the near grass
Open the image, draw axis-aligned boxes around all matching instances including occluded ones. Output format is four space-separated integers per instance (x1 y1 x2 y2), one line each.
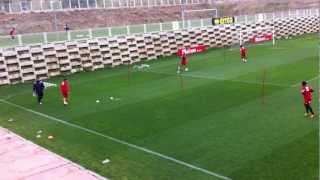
0 99 231 180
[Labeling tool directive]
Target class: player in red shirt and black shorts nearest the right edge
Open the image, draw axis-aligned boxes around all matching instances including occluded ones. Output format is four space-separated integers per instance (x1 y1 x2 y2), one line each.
301 81 314 118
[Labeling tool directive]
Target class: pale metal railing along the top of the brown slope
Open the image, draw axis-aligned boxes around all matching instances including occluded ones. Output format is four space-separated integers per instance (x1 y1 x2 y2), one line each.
0 0 207 13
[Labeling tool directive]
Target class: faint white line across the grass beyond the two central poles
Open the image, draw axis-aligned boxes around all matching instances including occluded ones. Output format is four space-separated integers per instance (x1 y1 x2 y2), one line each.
148 70 289 87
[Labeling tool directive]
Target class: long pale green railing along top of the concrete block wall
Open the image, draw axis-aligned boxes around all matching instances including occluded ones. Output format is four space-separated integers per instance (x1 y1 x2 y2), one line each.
0 9 319 47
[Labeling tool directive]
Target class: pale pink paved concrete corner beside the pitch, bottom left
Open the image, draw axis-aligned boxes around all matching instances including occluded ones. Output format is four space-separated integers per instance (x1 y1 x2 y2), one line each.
0 127 106 180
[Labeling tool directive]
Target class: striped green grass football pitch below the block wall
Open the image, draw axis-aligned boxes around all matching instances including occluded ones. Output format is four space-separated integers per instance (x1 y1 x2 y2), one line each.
0 34 319 180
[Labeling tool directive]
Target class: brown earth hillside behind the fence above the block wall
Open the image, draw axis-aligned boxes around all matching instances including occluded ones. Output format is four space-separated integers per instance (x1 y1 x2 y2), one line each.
0 0 319 35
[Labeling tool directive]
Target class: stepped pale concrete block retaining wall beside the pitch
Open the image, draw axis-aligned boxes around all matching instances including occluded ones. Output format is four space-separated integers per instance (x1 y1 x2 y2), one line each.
0 16 320 85
